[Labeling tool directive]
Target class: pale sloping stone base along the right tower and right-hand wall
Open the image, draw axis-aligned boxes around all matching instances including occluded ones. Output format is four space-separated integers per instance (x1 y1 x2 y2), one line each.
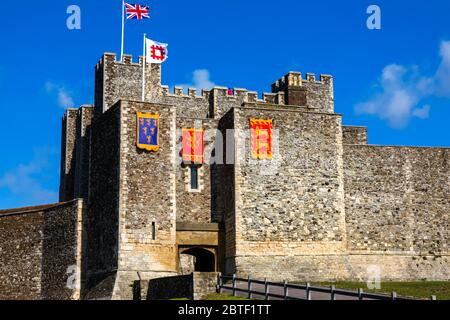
236 253 450 282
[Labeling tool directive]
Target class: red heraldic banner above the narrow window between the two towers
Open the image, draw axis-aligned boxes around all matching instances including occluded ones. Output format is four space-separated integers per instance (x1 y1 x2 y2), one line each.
182 128 205 164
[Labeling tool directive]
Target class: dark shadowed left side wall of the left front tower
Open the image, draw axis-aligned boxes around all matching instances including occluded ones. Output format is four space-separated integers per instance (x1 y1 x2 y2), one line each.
84 103 120 290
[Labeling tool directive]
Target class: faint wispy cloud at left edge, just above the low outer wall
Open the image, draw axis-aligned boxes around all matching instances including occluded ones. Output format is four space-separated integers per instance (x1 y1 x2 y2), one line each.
0 148 58 205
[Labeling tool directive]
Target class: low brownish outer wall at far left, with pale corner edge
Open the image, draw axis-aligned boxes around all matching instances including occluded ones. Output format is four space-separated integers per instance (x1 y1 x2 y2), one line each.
0 200 83 300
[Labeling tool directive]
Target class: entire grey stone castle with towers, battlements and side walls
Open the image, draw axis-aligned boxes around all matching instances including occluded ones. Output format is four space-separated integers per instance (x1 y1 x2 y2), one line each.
0 53 450 299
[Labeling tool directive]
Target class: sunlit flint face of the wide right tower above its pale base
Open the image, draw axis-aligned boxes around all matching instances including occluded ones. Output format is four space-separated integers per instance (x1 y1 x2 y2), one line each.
234 107 345 244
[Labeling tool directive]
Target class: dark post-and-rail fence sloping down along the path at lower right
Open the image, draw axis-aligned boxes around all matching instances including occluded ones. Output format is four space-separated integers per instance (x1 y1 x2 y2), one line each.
217 273 436 301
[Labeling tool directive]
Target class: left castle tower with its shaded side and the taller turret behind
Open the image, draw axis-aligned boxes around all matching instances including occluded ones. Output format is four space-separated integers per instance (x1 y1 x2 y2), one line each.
78 54 177 299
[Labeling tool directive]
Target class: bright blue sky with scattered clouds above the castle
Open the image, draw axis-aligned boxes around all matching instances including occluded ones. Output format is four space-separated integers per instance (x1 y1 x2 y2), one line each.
0 0 450 208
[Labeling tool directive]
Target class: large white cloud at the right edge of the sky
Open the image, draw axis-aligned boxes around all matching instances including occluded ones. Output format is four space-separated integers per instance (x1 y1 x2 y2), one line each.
355 41 450 129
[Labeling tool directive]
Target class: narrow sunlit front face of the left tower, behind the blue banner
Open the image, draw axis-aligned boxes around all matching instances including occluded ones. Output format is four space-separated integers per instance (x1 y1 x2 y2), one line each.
113 101 177 299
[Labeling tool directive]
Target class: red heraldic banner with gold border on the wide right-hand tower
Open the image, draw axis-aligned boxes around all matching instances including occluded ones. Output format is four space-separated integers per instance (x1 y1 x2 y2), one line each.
250 118 273 160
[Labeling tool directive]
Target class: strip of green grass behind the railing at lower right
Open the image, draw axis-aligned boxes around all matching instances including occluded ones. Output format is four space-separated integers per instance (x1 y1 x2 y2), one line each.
313 281 450 300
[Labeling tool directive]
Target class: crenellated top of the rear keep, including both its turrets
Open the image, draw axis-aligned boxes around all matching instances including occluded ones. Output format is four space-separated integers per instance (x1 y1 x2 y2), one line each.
95 53 334 116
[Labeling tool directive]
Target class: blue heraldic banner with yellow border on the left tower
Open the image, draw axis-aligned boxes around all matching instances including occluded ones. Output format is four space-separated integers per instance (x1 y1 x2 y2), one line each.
136 112 160 151
